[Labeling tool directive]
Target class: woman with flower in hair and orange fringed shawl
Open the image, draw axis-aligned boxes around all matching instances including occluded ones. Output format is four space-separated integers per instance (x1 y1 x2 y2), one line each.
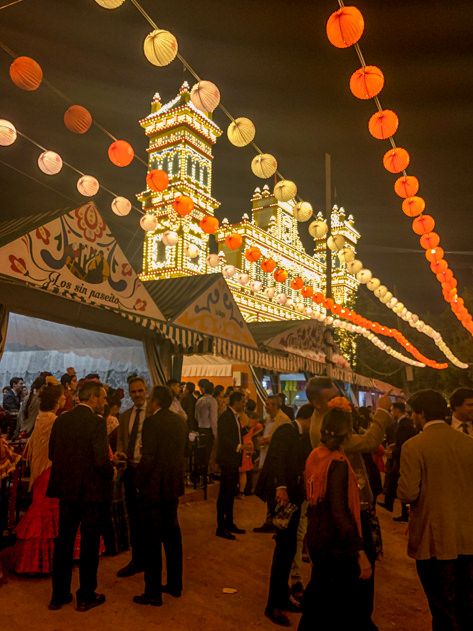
299 397 372 631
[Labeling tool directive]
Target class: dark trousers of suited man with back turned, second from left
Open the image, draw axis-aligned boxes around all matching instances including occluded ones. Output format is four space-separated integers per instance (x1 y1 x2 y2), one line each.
141 500 182 598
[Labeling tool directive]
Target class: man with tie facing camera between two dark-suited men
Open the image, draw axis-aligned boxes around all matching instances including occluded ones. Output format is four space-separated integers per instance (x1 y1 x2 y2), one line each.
117 377 148 578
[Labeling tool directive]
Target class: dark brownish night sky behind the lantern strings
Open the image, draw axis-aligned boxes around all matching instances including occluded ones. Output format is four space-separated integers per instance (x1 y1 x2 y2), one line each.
0 0 473 326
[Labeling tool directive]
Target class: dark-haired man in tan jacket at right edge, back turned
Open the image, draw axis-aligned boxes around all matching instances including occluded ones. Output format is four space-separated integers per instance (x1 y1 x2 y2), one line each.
397 390 473 631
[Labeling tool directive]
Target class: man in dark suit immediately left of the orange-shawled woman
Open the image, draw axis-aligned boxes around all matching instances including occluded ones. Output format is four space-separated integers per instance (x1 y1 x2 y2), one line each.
256 417 311 626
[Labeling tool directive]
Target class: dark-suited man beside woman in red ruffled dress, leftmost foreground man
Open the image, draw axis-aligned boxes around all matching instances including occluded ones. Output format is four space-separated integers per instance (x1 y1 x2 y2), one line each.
47 381 114 611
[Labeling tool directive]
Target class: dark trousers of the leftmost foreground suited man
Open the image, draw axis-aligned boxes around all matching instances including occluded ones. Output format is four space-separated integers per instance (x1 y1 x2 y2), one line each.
53 500 107 601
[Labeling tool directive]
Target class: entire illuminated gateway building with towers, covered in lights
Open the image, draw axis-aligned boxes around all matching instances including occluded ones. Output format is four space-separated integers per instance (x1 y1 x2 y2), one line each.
138 83 360 322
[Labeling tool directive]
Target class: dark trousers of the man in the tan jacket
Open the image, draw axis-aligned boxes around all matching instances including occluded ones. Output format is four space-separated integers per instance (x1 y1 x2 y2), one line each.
416 555 473 631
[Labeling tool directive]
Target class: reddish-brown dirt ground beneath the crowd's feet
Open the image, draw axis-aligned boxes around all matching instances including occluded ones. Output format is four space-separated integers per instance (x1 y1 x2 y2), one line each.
0 494 431 631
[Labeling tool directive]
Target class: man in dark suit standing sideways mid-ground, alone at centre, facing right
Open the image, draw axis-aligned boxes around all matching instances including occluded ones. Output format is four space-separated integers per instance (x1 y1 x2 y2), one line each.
216 392 247 539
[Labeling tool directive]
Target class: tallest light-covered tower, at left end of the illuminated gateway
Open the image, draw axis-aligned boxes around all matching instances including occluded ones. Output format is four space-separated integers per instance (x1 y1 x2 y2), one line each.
137 82 222 280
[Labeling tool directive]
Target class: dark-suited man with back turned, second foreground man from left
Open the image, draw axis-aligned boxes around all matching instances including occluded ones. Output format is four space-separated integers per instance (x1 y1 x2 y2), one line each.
133 386 187 606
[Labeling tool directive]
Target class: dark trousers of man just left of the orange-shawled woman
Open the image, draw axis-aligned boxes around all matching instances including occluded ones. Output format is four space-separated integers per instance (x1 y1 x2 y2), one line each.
266 506 301 609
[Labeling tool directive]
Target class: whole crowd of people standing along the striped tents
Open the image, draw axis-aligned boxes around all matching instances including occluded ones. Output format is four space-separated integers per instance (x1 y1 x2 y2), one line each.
0 369 473 631
